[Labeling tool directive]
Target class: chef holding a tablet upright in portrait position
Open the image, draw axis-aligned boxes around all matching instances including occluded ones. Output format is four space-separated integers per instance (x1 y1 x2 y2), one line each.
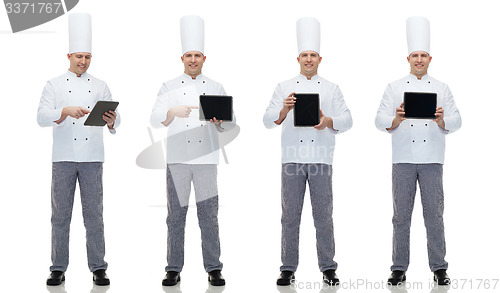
263 18 352 285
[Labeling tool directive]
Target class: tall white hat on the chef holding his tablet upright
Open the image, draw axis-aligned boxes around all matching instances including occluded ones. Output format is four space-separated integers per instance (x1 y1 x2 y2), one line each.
297 17 321 55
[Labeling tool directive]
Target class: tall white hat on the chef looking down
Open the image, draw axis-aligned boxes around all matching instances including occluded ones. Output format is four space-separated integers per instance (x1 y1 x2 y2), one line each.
68 13 92 54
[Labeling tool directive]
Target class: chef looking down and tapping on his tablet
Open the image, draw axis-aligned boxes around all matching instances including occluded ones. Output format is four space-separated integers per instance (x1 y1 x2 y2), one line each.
38 13 120 285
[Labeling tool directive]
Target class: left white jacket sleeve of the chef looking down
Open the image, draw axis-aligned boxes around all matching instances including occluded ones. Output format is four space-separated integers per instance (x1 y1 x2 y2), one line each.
37 81 62 127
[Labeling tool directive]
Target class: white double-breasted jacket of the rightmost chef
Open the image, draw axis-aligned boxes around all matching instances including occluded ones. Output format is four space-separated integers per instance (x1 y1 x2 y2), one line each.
375 74 462 164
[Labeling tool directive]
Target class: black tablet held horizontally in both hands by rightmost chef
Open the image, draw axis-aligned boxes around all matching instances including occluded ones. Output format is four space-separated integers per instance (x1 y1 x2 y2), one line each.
403 92 437 119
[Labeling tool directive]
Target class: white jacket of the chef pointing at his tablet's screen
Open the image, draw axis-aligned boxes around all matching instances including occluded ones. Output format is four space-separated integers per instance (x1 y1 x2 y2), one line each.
151 73 235 165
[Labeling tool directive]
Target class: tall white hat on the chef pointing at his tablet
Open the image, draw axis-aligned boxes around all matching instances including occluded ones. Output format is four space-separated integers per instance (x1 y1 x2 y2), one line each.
181 15 205 55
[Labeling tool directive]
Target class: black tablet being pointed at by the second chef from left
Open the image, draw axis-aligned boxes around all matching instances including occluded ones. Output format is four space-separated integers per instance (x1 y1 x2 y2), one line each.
200 95 233 121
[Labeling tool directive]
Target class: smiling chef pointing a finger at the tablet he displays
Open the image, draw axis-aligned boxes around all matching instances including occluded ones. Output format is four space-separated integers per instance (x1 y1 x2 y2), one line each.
151 16 235 286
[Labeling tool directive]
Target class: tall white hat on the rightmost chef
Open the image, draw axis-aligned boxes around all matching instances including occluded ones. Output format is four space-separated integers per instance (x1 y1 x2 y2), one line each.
406 16 431 56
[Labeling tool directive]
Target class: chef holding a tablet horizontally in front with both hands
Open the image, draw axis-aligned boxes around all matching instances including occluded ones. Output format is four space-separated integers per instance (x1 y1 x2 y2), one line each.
375 17 462 285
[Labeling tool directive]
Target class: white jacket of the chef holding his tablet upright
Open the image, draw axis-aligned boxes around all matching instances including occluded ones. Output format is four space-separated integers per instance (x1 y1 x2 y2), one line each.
264 74 352 165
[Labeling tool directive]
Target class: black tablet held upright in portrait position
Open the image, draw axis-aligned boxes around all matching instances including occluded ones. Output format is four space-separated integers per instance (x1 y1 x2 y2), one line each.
293 93 319 127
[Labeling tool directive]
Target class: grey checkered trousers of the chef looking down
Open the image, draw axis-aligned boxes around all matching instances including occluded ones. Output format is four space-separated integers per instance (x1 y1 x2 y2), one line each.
50 162 108 272
